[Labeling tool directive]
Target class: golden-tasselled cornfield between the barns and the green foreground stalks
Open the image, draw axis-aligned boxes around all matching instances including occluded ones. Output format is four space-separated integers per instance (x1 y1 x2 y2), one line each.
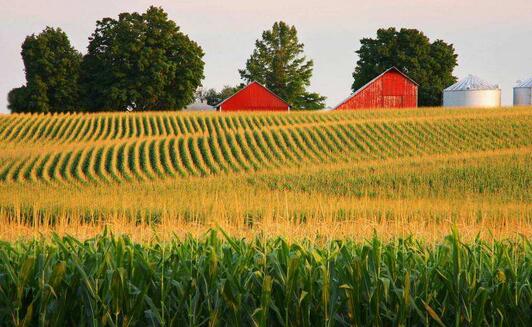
0 108 532 241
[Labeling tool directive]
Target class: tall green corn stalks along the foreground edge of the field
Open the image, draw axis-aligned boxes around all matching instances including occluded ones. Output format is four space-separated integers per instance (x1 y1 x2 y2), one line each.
0 231 532 326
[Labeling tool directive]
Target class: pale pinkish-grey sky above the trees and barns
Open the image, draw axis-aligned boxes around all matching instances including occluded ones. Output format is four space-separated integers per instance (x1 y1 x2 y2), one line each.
0 0 532 113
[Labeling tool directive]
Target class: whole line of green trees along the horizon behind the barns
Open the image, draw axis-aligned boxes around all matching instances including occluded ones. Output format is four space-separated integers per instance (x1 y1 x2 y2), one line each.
8 6 457 112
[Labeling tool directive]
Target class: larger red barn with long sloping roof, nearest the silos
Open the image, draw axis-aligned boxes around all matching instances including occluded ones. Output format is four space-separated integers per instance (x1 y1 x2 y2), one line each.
335 67 418 110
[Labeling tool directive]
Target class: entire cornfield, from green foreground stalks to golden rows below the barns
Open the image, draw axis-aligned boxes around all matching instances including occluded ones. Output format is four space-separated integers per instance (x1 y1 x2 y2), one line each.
0 107 532 326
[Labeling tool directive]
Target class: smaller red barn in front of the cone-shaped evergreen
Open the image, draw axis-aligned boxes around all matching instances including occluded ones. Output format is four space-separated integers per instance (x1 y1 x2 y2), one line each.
217 82 290 111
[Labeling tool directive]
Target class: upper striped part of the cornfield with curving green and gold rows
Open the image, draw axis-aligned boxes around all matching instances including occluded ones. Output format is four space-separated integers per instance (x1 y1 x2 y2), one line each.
0 109 532 185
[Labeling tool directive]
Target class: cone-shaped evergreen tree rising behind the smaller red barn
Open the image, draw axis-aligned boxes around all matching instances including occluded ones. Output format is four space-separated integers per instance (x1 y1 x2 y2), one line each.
239 22 326 109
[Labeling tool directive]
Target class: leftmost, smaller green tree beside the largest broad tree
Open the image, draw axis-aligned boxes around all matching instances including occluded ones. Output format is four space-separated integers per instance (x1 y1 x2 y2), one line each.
8 27 81 112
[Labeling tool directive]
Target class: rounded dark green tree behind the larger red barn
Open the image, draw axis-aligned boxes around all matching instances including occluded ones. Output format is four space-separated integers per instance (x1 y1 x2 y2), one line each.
352 28 458 106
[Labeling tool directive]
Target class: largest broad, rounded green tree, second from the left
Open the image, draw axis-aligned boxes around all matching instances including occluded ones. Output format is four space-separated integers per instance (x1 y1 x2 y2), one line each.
82 6 204 111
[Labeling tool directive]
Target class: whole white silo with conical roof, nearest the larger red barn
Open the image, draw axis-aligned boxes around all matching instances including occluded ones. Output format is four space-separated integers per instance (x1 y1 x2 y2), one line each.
443 75 501 108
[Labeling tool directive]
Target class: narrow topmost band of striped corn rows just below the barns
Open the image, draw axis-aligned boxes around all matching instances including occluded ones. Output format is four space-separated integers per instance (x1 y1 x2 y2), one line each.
0 109 531 144
